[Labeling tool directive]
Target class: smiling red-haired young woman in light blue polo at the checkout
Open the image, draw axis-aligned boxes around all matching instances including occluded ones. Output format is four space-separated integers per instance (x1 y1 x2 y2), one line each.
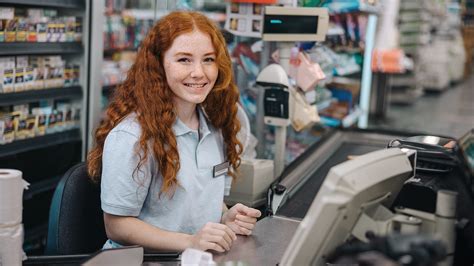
88 12 261 252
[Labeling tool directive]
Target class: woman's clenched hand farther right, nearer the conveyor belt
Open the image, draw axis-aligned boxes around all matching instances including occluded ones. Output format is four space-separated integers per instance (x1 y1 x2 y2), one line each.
221 203 262 235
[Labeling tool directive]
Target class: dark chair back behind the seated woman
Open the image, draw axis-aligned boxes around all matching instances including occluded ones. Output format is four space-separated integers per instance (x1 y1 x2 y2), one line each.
45 163 107 255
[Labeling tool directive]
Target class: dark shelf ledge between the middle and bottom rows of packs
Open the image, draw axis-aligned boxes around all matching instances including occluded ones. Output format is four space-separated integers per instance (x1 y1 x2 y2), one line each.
0 86 82 106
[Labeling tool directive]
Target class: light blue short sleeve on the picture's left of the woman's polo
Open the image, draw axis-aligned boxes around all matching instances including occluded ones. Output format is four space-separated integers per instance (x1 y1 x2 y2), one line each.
101 130 153 216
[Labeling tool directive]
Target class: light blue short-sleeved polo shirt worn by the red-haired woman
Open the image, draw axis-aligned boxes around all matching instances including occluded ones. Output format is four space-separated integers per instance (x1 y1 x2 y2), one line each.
101 107 232 248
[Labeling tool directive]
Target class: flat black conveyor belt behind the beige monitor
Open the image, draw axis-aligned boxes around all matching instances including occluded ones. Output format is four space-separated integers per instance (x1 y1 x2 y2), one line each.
278 143 384 219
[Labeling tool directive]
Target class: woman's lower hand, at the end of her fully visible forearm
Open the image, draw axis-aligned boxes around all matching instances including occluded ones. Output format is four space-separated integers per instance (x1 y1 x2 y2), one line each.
191 222 237 252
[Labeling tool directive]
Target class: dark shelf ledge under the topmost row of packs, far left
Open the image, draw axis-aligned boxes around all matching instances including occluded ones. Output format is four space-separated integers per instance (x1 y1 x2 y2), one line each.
0 42 84 55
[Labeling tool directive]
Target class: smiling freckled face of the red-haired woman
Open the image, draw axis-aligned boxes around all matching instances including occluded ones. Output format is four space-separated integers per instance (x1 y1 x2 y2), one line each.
163 30 219 107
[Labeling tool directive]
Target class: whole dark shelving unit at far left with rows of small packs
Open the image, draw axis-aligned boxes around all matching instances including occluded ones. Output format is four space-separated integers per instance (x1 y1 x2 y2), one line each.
0 0 90 255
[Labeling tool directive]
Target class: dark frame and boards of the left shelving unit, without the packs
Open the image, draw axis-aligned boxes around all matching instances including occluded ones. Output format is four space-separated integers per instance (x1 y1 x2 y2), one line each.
0 0 90 255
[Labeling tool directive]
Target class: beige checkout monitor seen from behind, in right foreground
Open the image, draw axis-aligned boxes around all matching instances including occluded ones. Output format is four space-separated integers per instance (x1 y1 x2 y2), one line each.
280 148 416 265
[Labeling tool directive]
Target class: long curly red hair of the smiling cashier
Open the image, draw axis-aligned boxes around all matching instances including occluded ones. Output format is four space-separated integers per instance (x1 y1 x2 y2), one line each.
87 11 242 195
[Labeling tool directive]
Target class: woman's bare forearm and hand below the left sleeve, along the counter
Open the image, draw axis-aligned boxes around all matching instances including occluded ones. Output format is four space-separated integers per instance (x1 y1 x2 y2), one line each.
104 213 236 252
